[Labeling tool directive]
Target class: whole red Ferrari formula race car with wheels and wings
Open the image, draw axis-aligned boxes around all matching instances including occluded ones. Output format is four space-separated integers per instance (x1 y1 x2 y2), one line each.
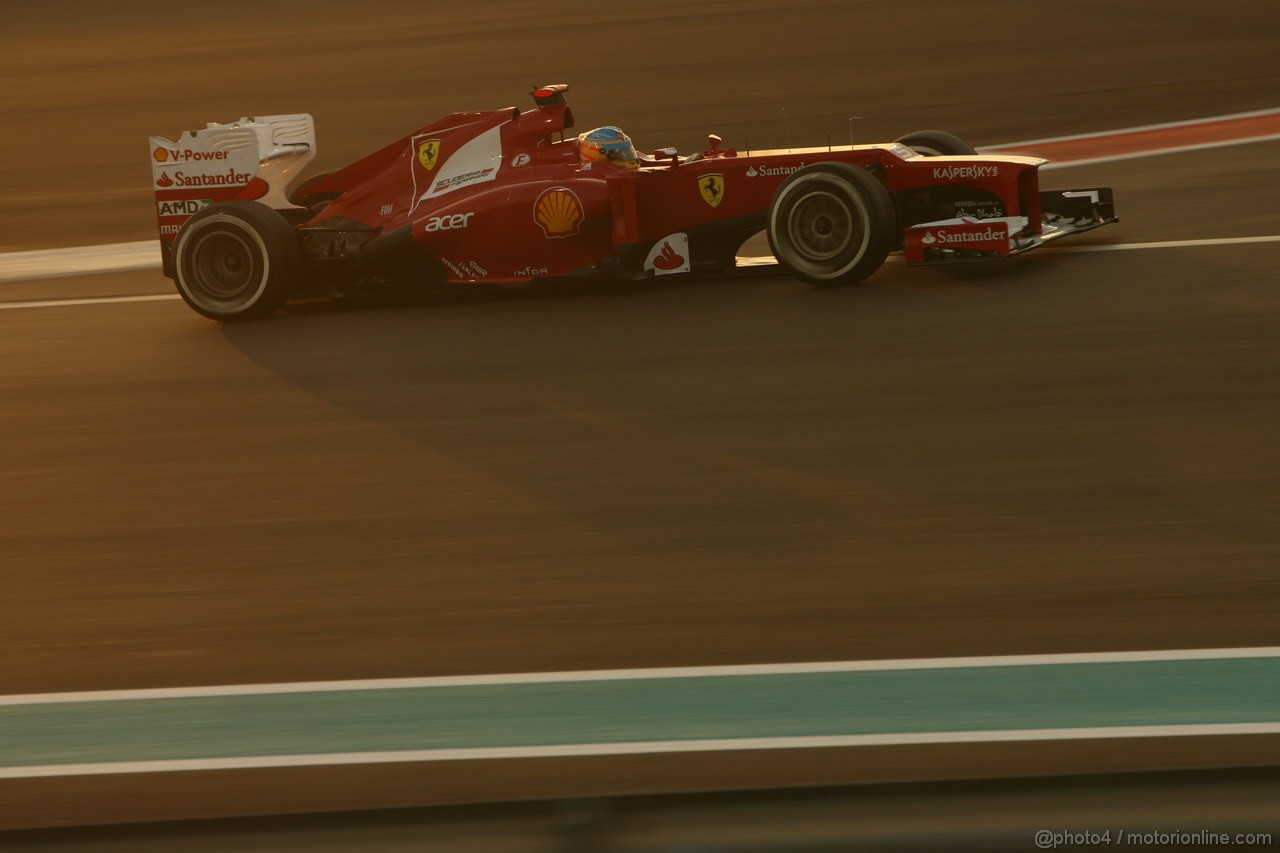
151 85 1116 320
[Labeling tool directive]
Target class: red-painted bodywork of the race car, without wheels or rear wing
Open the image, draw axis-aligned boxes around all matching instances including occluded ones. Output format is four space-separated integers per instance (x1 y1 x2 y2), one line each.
285 87 1105 283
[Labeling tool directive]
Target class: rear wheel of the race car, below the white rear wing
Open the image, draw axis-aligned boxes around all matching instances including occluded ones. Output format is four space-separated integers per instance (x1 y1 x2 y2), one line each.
173 201 302 323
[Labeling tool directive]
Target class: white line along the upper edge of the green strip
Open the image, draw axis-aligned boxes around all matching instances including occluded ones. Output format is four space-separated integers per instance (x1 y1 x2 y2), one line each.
0 646 1280 707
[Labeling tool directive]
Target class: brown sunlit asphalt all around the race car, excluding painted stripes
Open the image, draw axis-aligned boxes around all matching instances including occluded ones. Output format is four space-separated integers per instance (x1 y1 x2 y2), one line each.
0 3 1280 826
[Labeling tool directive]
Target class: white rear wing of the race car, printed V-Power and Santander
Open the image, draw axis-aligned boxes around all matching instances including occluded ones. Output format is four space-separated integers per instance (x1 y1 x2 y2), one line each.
151 113 316 249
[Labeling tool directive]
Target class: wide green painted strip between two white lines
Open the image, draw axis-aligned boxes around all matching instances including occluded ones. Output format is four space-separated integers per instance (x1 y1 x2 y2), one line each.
0 658 1280 767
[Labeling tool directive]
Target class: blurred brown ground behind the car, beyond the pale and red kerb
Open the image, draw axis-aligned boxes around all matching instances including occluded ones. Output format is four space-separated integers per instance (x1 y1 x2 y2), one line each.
0 0 1276 251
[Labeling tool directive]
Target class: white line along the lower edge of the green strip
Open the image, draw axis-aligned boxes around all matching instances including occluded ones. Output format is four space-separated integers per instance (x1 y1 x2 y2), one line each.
0 722 1280 779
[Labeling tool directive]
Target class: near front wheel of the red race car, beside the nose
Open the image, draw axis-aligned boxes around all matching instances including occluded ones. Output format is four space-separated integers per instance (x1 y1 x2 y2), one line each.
767 163 897 287
